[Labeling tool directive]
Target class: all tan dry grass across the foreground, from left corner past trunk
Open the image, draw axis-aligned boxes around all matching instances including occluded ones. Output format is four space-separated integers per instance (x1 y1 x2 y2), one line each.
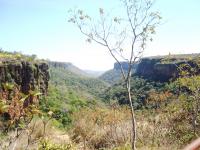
0 106 178 150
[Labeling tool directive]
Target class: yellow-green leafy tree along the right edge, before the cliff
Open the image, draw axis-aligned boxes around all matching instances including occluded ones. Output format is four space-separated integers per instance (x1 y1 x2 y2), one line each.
166 57 200 144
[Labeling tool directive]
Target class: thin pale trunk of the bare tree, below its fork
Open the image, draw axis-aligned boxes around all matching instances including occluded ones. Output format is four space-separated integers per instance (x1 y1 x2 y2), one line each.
126 77 136 150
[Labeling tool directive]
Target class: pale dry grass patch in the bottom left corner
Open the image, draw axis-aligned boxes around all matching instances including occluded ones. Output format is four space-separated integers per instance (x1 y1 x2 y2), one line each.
0 119 71 150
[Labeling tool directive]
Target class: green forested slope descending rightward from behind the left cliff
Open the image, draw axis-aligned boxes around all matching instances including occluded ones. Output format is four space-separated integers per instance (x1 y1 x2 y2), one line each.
39 62 108 127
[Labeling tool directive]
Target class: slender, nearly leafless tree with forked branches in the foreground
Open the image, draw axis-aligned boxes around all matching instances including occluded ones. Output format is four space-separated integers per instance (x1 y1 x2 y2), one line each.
69 0 161 150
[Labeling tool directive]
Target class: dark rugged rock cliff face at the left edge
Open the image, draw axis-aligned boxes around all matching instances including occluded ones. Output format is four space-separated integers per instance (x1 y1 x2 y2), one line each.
0 60 49 94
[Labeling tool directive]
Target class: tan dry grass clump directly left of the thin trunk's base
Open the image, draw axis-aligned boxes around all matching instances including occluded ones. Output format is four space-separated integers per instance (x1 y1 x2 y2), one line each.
71 107 131 149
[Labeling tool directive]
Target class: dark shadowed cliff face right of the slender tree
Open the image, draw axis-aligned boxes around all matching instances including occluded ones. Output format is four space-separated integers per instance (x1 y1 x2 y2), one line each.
135 57 200 82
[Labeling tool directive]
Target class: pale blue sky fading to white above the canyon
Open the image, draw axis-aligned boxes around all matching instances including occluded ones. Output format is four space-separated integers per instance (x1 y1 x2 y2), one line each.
0 0 200 71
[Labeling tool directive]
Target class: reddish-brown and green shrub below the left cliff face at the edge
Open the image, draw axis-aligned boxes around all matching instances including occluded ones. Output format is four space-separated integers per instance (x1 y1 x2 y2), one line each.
0 83 40 148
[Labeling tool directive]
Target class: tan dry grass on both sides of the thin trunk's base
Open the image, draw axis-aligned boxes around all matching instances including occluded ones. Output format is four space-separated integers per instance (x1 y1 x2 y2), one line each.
71 107 180 150
